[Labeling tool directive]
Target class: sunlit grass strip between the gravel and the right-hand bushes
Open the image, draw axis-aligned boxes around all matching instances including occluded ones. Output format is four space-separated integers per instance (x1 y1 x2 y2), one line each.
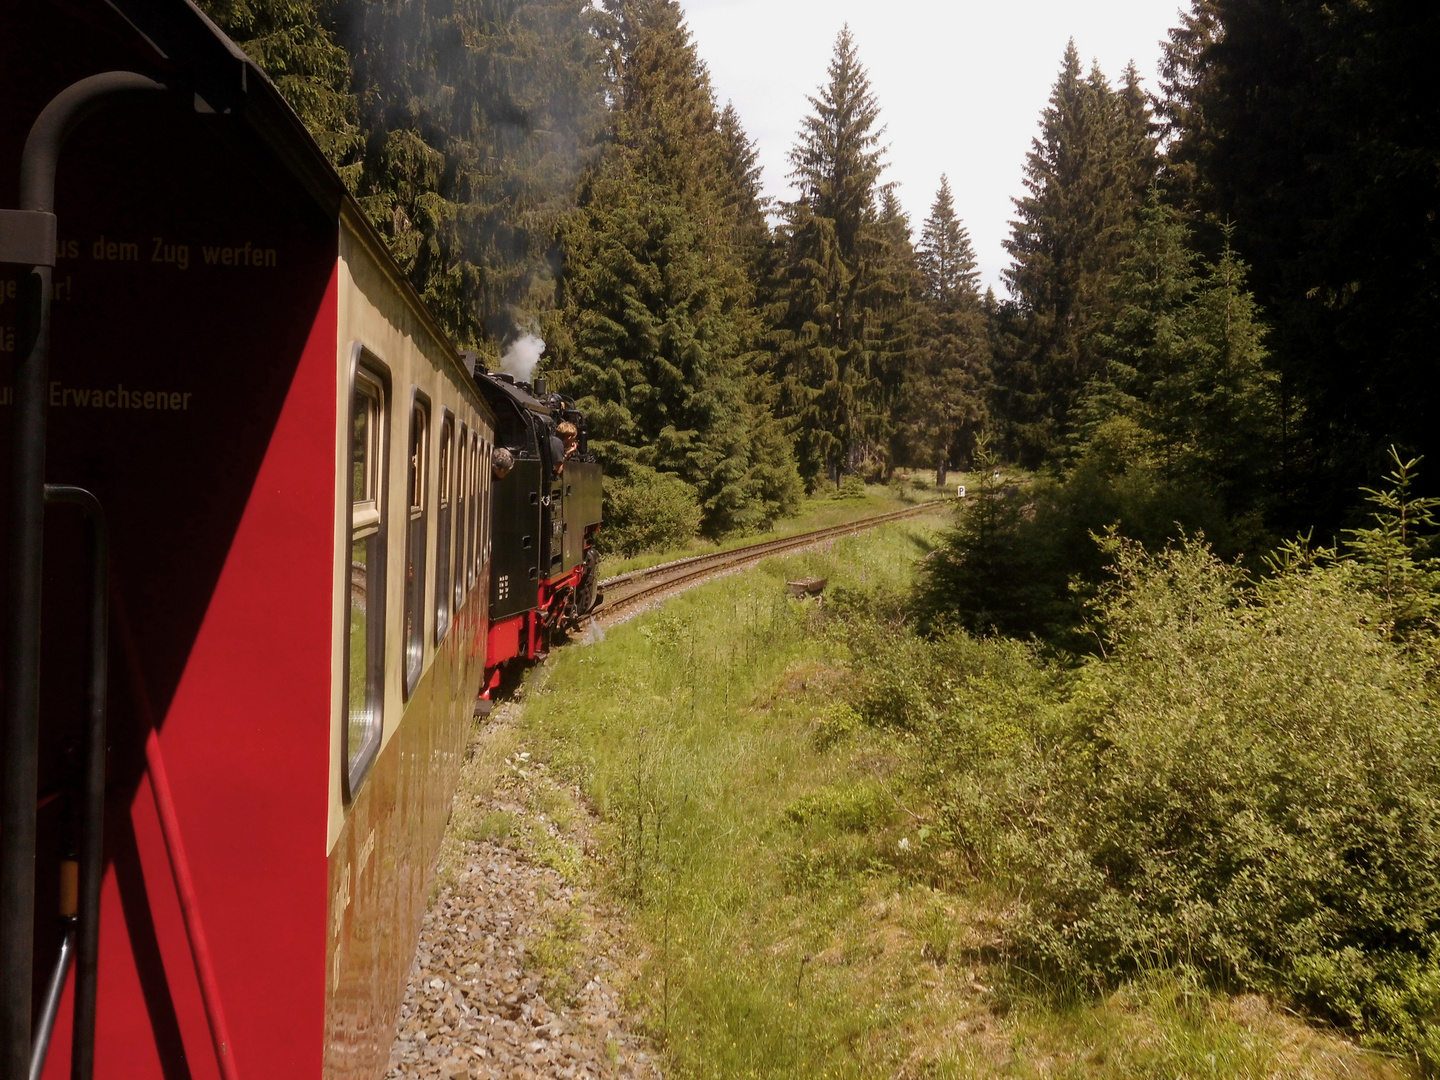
507 520 1405 1080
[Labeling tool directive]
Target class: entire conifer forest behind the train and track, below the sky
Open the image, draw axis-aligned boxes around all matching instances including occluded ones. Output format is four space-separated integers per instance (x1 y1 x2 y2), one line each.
203 0 1440 552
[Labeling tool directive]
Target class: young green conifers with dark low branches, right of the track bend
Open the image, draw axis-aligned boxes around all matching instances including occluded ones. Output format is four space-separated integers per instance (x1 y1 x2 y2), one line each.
919 189 1282 649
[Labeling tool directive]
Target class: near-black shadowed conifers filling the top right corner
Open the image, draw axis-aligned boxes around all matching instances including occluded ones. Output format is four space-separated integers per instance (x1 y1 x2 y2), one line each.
1159 0 1440 528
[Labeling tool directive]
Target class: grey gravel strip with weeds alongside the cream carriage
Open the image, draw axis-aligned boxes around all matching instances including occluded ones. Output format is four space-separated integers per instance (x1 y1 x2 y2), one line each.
386 704 661 1080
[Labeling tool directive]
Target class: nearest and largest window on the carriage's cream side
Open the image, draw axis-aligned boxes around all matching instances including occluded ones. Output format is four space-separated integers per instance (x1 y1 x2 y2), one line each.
344 369 384 795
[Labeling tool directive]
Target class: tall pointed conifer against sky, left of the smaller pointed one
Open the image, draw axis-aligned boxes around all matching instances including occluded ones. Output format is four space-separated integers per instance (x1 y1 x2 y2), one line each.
772 26 884 485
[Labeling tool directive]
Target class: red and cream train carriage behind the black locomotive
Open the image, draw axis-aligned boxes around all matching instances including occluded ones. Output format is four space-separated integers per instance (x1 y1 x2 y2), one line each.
0 0 495 1080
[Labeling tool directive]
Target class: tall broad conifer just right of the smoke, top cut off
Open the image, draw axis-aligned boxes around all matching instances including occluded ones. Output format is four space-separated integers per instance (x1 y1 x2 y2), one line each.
566 0 798 533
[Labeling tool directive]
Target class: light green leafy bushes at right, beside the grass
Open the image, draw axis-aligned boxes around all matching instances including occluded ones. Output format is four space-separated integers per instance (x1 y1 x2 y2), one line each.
851 466 1440 1068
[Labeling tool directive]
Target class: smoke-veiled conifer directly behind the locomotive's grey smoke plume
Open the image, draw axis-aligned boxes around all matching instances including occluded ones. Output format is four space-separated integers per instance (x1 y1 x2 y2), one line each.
334 0 606 351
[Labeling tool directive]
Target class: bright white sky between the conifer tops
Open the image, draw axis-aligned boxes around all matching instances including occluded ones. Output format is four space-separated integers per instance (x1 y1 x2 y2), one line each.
681 0 1188 295
